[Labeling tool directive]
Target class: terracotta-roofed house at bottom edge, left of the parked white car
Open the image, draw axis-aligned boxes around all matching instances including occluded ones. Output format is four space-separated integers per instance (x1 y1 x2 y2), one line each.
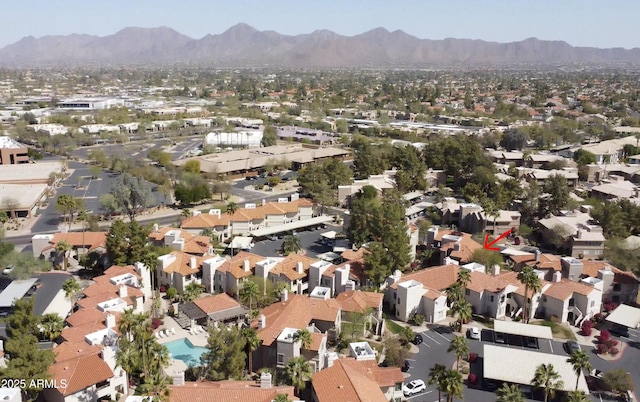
311 358 404 402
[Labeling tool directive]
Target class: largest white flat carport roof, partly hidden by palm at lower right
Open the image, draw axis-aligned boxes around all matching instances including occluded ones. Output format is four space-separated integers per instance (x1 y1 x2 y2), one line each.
482 344 589 394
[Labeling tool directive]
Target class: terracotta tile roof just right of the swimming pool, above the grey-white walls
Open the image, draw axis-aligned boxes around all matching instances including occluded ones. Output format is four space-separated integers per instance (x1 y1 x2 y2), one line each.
251 294 340 346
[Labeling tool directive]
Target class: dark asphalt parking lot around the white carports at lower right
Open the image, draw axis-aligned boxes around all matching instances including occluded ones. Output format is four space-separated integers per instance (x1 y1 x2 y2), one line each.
405 325 640 402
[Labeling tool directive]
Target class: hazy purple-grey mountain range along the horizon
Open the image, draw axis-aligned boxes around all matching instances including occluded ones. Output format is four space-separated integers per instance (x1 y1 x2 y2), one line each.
0 24 640 68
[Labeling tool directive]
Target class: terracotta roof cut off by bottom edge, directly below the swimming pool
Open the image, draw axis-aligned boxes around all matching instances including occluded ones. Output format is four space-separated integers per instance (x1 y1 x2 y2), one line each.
169 381 297 402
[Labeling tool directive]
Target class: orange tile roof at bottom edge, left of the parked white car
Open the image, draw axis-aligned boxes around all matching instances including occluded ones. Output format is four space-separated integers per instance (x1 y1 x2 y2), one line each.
311 359 396 402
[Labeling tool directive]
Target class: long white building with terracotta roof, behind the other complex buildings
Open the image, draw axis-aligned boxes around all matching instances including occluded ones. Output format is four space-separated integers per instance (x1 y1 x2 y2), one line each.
181 196 320 241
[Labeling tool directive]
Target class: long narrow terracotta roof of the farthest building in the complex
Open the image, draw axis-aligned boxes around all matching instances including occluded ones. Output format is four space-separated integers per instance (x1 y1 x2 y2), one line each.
180 198 313 229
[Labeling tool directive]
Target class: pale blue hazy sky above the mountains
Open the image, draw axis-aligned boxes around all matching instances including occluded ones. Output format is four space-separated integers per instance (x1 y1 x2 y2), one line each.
0 0 640 48
